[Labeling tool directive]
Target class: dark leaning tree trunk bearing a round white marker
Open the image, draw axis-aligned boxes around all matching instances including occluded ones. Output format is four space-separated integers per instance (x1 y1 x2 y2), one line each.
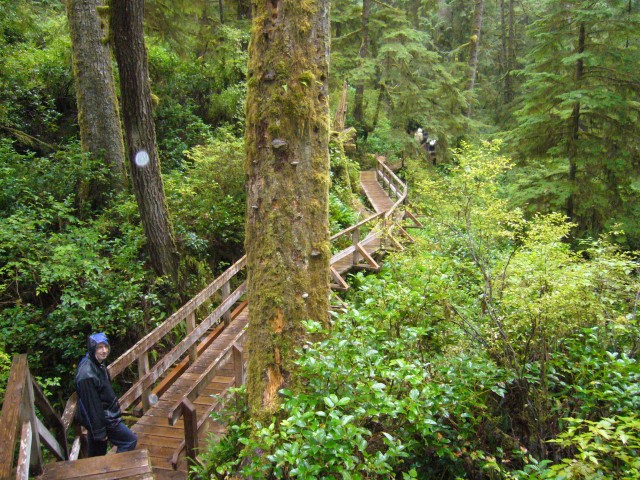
110 0 179 282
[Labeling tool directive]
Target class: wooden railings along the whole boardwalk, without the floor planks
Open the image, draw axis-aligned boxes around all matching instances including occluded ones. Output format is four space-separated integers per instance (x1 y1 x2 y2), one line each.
0 160 411 472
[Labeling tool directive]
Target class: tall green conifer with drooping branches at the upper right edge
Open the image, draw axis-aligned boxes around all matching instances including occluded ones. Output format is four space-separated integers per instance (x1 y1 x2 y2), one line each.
511 0 640 246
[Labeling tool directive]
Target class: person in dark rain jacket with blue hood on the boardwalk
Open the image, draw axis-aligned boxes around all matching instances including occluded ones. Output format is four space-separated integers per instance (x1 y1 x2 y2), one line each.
76 333 138 457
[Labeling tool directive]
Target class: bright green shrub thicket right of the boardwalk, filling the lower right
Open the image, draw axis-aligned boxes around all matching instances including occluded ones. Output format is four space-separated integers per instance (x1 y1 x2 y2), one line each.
199 144 640 479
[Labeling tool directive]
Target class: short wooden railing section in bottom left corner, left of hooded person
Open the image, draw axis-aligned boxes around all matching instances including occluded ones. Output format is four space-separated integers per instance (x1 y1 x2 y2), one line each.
0 354 69 480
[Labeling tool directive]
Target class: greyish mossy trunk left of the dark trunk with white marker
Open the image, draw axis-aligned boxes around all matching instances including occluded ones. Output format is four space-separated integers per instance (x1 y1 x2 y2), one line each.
67 0 126 205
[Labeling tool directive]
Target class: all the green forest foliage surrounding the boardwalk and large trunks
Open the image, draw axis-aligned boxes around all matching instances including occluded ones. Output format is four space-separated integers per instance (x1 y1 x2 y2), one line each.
0 0 640 479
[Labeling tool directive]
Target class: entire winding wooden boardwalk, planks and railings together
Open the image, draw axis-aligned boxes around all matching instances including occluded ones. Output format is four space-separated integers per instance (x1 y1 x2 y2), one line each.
0 160 419 480
